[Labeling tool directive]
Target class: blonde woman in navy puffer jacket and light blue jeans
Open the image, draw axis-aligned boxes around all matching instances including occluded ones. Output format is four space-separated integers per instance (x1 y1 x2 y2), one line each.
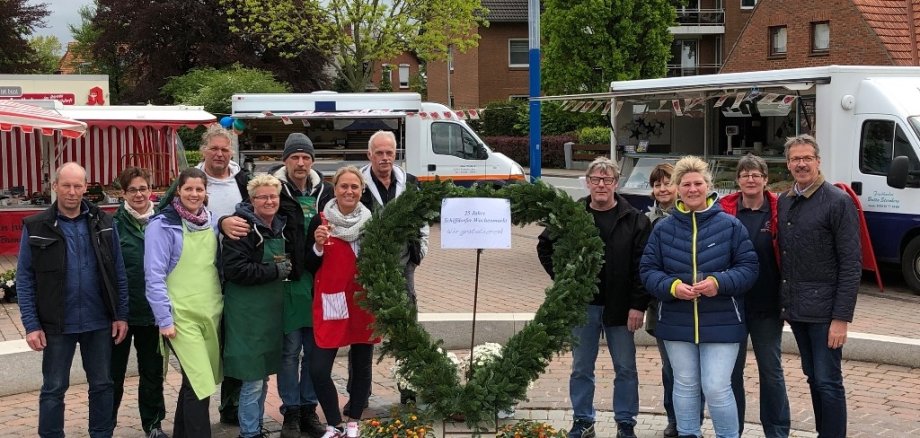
639 156 758 438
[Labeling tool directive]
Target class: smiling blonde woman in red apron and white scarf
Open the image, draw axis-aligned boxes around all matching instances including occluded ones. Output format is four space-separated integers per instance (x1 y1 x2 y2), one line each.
307 166 380 438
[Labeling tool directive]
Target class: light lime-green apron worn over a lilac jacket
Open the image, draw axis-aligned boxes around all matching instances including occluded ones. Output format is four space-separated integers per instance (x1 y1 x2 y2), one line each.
164 222 223 400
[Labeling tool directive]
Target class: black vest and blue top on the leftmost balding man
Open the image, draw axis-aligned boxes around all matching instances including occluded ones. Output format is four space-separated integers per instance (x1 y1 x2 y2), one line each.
16 201 128 334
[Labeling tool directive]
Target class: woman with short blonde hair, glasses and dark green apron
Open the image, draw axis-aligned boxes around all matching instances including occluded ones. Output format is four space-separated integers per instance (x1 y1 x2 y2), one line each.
221 174 291 438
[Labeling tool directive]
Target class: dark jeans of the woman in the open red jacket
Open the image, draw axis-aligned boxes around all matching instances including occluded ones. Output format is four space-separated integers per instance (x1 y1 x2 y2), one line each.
732 317 789 438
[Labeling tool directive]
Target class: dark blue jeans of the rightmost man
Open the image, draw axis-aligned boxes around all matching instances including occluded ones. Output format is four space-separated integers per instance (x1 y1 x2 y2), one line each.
789 321 847 438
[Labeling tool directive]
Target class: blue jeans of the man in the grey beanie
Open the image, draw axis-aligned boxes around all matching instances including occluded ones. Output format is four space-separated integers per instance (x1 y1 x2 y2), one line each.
278 327 317 415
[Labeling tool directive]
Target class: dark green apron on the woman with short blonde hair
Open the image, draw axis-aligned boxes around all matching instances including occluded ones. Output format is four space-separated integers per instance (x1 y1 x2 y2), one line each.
224 239 288 381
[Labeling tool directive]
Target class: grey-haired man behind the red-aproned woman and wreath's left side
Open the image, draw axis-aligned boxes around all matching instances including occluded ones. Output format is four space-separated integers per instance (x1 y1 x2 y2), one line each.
361 131 429 403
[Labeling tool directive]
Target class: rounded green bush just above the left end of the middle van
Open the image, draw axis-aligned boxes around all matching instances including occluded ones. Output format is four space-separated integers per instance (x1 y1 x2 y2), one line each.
162 64 291 114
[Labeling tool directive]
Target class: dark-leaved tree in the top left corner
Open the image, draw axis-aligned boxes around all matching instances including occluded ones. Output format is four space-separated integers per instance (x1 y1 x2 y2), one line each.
0 0 49 73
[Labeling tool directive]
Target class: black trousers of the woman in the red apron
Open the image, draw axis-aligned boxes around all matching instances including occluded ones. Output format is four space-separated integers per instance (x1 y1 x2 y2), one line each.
310 344 374 426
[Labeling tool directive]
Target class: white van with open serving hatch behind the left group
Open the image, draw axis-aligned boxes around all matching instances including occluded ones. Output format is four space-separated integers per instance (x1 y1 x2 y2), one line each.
232 91 524 185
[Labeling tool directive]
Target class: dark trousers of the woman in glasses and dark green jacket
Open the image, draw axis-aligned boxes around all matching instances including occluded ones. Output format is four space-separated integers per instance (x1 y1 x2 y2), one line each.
112 325 166 433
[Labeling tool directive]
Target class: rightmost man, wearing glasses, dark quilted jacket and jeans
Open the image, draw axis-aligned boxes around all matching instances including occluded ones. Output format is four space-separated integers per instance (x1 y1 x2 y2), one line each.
777 135 862 437
